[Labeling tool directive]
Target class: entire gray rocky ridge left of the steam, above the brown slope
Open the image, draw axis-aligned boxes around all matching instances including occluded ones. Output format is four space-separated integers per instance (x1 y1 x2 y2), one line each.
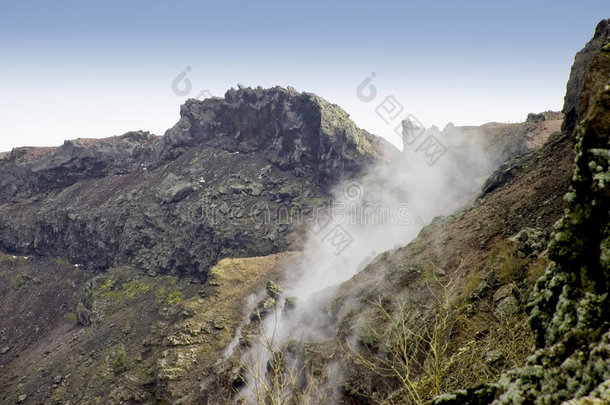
0 87 392 277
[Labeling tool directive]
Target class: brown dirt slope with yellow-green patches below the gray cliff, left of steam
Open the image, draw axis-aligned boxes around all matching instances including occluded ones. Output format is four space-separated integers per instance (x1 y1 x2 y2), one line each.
0 253 292 404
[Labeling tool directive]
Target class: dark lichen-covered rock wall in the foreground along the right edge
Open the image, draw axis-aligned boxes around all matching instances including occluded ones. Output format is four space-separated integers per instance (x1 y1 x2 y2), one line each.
436 20 610 405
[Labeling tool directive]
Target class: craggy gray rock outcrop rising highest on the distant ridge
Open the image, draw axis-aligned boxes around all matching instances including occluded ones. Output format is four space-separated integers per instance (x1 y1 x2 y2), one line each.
161 87 383 185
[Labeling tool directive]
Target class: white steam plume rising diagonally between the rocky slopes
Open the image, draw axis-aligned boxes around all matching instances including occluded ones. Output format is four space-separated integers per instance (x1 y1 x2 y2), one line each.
235 124 493 403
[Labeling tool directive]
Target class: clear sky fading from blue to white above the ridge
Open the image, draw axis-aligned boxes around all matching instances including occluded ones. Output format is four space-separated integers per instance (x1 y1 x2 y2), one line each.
0 0 610 151
